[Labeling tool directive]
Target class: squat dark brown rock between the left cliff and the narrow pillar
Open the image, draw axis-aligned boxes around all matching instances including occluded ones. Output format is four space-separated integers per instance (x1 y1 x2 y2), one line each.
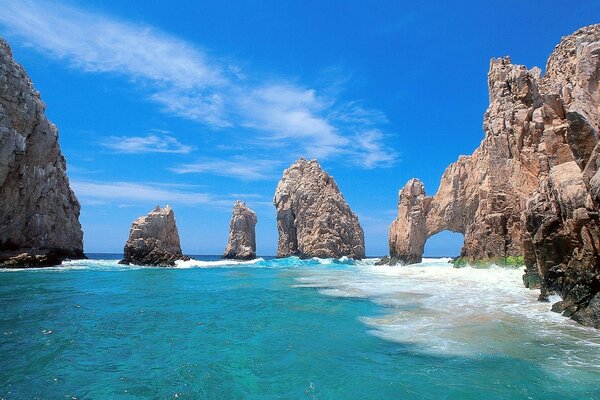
120 206 189 266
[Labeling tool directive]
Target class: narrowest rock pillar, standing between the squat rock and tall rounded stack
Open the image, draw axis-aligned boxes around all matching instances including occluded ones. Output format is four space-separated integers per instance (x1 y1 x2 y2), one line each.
223 201 256 260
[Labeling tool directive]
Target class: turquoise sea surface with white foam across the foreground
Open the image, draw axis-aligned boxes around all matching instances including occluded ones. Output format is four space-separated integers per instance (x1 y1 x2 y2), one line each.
0 254 600 400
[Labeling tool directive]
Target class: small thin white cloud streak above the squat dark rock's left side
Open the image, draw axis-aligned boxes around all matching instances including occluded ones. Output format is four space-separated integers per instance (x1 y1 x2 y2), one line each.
102 135 194 154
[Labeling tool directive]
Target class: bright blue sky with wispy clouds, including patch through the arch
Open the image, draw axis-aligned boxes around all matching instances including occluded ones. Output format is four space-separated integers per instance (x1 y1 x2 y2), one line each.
0 0 600 255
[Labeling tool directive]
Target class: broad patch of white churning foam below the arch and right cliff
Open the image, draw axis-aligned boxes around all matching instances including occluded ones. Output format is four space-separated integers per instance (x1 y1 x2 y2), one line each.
295 258 600 373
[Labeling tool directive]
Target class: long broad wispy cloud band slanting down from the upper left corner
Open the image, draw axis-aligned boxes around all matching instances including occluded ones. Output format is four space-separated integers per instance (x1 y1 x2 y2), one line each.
0 0 396 168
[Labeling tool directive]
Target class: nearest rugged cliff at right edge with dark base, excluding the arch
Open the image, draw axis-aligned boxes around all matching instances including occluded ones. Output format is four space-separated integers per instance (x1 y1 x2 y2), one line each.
523 25 600 328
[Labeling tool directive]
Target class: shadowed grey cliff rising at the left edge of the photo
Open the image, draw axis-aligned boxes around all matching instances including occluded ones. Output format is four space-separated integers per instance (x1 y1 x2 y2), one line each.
0 39 84 267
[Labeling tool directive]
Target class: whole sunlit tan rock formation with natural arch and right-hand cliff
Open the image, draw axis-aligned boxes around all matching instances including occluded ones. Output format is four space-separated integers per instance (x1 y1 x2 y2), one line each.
390 25 600 327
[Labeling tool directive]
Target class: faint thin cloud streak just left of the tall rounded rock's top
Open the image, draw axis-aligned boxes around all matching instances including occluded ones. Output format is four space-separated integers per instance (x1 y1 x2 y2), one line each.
170 157 279 180
